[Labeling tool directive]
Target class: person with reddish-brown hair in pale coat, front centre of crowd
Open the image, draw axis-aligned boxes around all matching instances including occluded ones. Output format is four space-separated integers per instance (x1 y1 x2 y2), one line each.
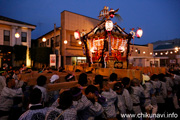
99 79 117 119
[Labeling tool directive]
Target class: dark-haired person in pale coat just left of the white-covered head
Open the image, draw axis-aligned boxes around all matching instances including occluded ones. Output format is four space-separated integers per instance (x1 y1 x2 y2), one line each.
34 75 48 104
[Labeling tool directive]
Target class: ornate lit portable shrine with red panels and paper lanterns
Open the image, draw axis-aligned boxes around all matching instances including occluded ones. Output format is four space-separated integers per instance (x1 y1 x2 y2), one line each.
74 6 142 68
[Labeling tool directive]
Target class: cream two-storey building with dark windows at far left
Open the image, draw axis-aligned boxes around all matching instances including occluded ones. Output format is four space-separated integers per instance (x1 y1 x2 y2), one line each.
0 16 36 67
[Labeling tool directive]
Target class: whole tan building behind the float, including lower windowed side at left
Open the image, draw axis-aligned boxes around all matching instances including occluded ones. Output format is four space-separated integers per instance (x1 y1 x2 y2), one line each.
38 11 100 68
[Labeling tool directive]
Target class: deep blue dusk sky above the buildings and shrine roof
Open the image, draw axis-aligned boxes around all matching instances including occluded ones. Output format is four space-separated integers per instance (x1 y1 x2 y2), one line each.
0 0 180 44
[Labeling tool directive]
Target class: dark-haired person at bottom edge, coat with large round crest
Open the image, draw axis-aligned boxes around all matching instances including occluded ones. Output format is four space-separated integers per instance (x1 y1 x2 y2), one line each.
46 90 77 120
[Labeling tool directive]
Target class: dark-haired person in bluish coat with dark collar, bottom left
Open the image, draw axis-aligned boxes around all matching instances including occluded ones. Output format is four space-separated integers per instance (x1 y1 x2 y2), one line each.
19 88 48 120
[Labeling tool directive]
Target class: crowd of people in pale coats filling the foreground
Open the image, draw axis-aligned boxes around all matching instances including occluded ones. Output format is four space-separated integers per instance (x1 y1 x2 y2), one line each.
0 65 180 120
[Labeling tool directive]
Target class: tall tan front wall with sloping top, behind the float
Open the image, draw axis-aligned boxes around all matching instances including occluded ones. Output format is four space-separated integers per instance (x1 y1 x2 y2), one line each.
61 11 100 65
